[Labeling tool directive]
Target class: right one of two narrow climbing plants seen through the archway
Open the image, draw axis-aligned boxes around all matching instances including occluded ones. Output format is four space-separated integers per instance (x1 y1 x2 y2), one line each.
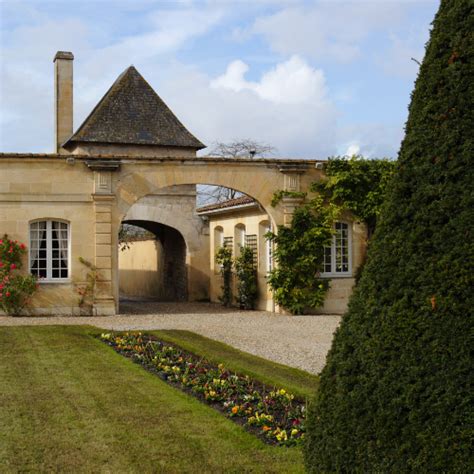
234 247 258 309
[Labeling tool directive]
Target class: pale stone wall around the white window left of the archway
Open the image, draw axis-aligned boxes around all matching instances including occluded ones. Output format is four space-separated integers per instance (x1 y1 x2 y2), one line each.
0 159 95 315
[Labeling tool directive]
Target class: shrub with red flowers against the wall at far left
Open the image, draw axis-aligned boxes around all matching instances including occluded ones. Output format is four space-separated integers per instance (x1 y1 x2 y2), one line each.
0 234 37 315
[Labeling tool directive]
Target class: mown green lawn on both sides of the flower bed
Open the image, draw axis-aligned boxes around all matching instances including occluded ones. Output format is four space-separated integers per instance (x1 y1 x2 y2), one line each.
0 326 315 473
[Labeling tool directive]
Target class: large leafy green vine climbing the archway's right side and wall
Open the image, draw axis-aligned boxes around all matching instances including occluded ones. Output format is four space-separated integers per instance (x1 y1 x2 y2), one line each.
267 156 396 314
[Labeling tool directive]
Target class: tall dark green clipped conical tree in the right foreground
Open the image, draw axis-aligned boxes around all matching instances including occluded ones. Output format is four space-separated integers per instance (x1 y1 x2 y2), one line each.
305 0 474 472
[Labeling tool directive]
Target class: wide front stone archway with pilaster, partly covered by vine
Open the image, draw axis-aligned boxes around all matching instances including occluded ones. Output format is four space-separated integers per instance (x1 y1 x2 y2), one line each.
87 157 323 314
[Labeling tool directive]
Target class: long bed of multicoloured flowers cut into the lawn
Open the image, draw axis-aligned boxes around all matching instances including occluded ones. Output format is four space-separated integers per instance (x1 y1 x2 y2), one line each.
101 332 305 446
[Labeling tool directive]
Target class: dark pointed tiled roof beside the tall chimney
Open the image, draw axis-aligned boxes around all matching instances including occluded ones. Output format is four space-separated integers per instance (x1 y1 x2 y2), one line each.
64 66 205 150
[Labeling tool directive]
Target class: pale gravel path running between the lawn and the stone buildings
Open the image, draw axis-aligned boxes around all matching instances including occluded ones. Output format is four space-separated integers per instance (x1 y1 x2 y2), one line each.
0 301 340 374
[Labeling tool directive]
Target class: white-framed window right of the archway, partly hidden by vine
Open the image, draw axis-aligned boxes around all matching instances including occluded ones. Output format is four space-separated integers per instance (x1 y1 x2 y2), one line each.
321 222 352 277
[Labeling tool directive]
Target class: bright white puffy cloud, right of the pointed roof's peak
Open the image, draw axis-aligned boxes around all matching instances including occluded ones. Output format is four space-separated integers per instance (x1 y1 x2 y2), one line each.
211 56 326 104
